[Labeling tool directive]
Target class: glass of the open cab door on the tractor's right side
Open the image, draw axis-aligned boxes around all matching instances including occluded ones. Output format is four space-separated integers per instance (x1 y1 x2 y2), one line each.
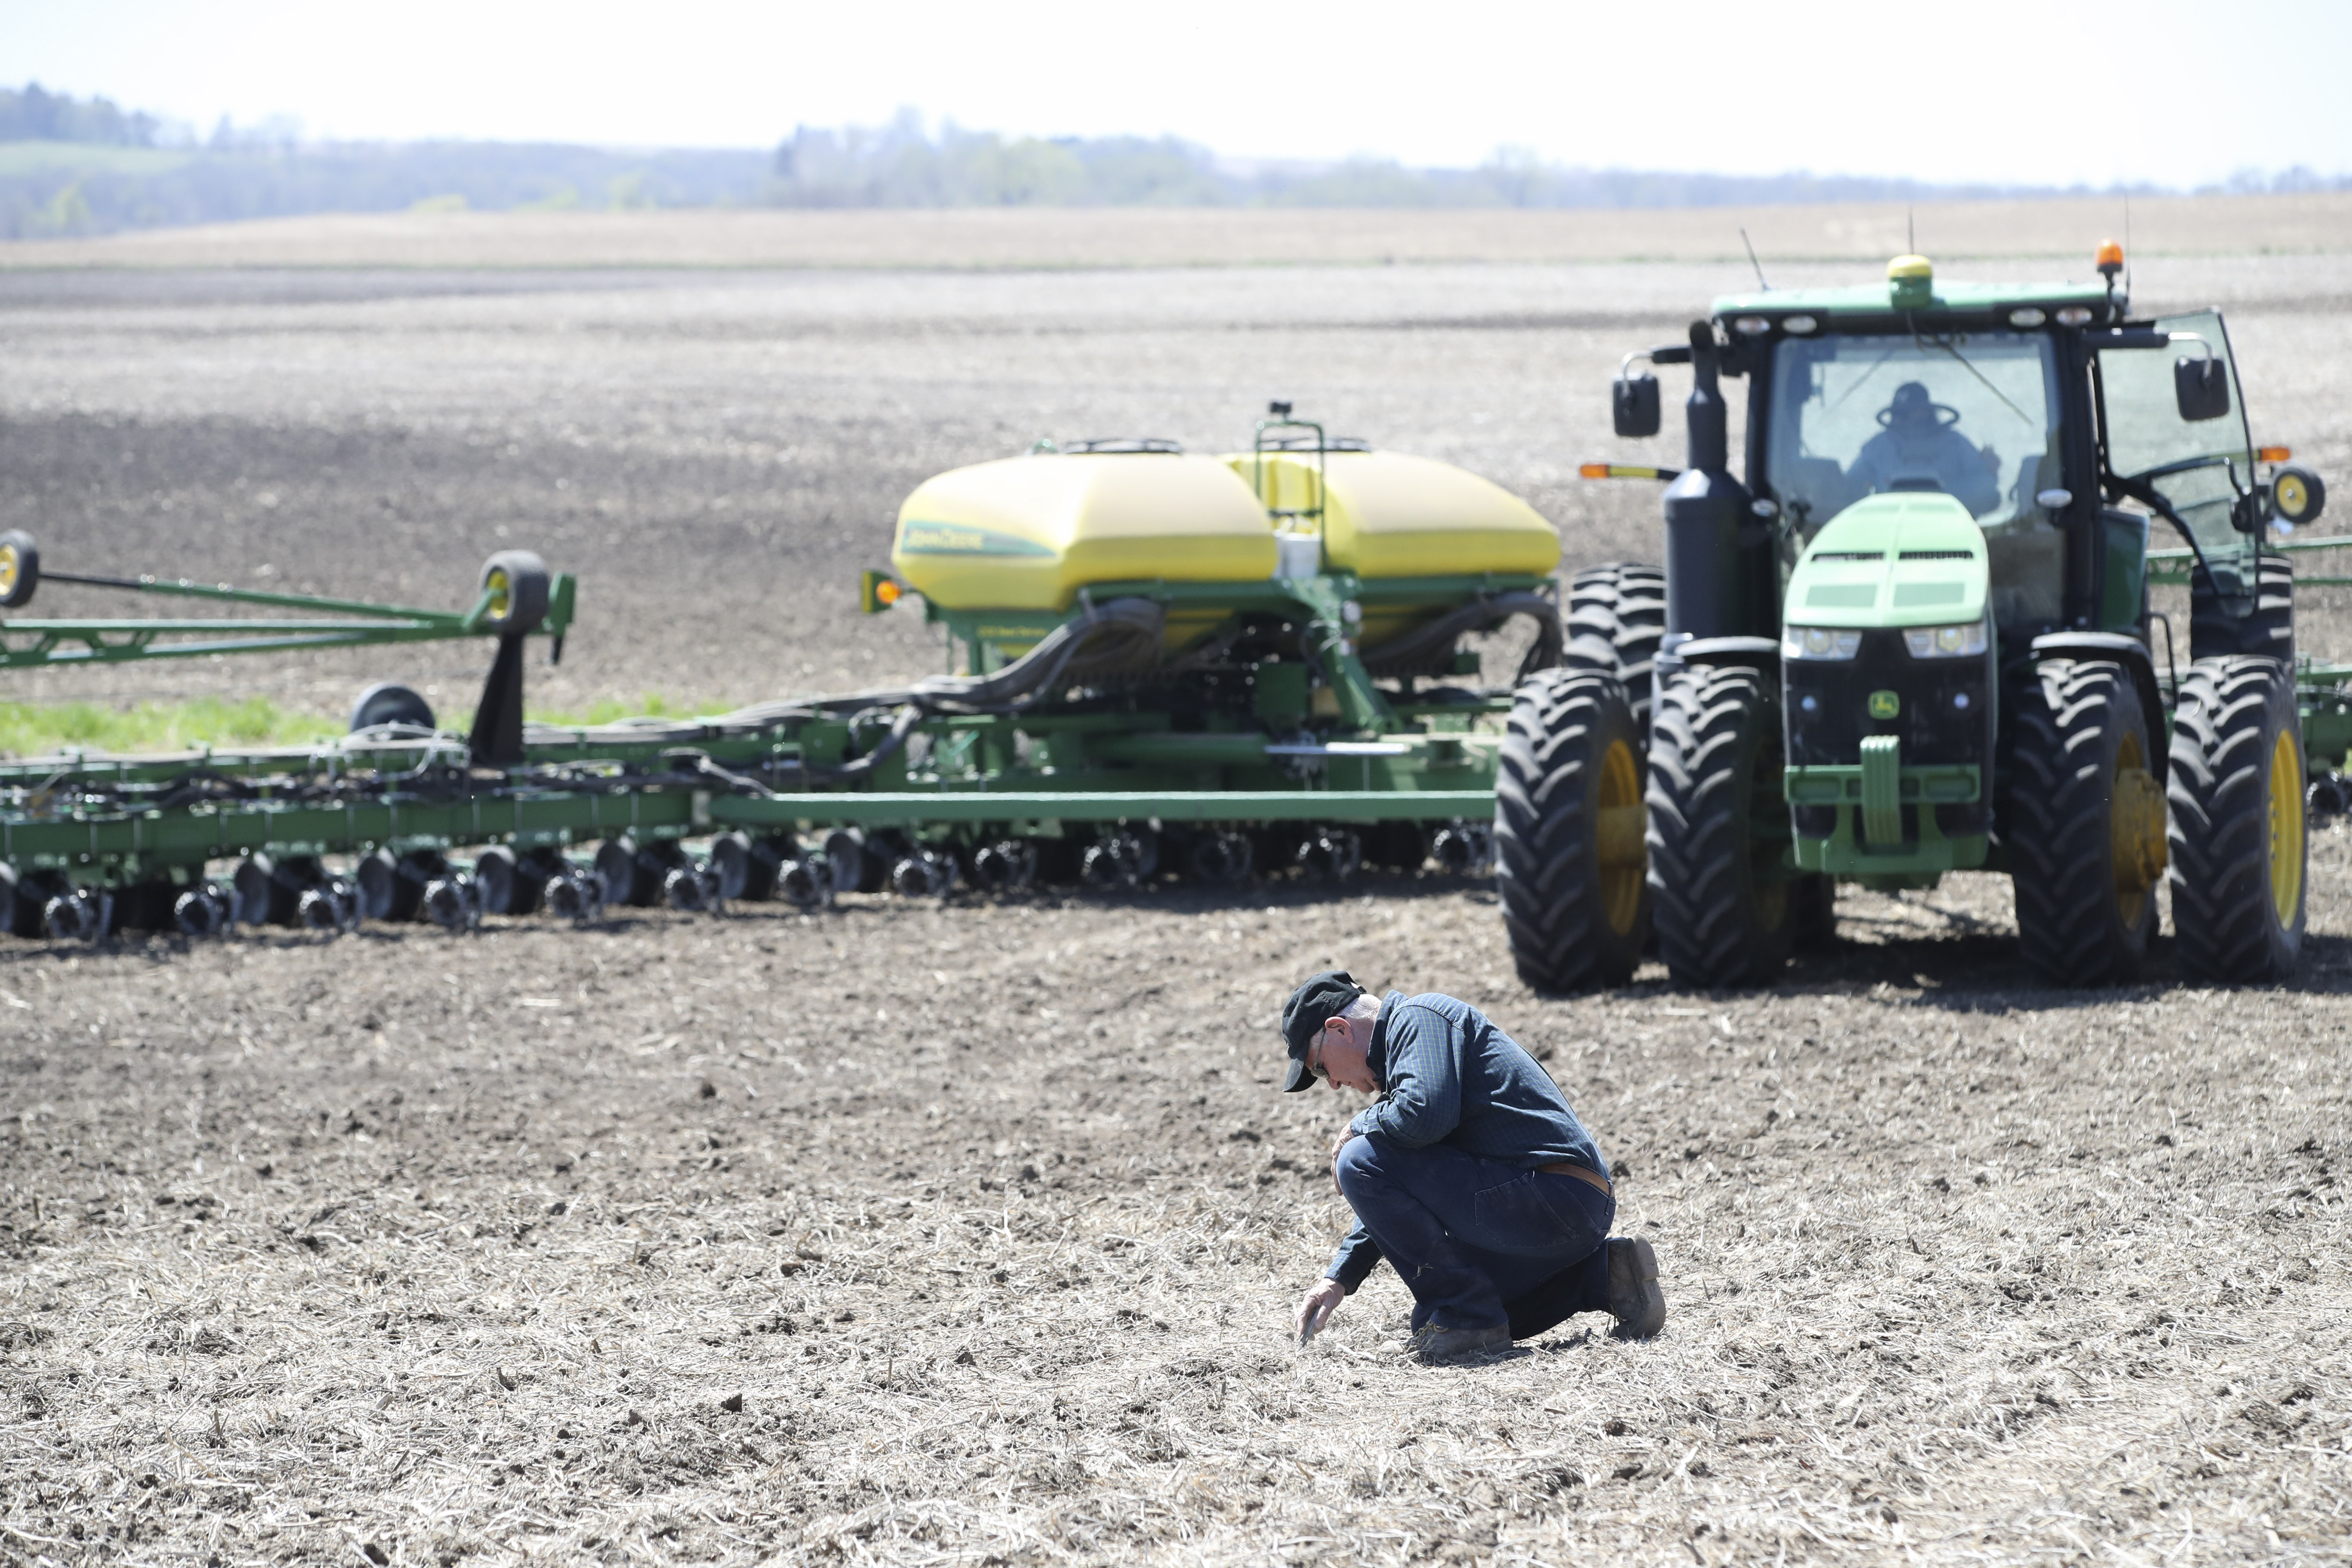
2098 310 2256 592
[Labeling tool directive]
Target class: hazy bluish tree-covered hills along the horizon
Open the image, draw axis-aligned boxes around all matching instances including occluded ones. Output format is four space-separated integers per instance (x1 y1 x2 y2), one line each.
0 85 2352 240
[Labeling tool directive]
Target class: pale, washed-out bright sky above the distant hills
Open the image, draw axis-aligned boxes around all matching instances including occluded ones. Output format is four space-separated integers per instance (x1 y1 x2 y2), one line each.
0 0 2352 186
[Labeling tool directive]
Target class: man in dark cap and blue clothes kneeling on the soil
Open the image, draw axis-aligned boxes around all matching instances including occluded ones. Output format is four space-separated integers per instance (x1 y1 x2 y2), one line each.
1282 968 1665 1363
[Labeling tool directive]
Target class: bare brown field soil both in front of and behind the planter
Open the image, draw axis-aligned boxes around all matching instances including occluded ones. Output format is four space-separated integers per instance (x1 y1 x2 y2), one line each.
0 215 2352 1566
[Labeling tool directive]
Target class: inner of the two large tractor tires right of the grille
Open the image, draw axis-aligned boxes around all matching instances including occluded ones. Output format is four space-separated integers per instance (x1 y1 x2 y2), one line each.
1999 658 2166 985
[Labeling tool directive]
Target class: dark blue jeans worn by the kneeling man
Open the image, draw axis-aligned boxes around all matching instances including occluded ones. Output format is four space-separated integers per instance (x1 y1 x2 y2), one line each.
1338 1133 1616 1340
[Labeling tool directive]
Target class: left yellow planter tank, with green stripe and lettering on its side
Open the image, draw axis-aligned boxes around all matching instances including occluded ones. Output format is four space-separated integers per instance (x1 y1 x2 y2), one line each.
891 451 1275 611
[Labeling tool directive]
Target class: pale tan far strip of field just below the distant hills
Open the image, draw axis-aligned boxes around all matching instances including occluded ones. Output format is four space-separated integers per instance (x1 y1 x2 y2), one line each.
14 190 2352 270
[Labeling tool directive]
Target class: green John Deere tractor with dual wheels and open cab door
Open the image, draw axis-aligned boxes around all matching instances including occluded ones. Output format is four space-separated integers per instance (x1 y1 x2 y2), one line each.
1496 245 2352 990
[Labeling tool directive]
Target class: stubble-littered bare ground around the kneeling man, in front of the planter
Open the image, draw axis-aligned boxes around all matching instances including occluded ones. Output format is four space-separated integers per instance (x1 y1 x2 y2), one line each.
0 865 2347 1561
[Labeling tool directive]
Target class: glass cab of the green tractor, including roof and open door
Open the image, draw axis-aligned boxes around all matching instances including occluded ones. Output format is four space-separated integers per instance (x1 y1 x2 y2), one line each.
1712 247 2269 649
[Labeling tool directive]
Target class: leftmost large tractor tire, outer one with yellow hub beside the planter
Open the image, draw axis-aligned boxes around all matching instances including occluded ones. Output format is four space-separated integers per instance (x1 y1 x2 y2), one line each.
1494 670 1649 992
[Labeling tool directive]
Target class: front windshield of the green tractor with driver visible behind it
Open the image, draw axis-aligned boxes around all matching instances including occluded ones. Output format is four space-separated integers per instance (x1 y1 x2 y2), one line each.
1764 331 2065 628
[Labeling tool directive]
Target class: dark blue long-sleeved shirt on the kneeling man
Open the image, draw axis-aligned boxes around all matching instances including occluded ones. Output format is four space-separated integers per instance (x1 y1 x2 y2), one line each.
1324 992 1609 1291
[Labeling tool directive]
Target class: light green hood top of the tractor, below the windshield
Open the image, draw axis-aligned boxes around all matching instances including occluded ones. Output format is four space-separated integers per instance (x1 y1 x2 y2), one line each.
1783 491 1988 630
